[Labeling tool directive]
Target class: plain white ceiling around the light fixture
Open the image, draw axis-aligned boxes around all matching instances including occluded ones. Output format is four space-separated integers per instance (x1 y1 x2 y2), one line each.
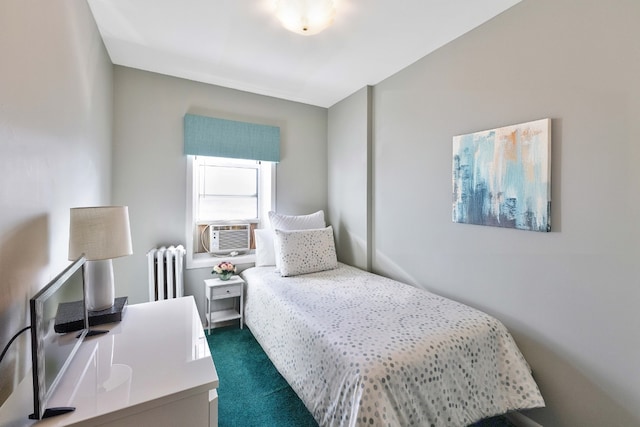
88 0 520 107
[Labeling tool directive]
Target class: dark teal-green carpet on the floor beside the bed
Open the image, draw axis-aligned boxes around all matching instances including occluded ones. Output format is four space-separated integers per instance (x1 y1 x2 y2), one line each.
207 326 514 427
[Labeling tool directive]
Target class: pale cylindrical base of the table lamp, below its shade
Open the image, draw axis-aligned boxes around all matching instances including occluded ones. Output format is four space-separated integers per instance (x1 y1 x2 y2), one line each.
84 259 115 311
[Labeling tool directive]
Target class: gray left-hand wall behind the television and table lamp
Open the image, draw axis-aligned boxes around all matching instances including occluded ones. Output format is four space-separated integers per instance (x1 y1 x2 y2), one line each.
0 0 113 404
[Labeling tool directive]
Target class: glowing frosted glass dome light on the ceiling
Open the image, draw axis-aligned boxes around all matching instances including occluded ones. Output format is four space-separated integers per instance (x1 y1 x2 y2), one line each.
276 0 336 36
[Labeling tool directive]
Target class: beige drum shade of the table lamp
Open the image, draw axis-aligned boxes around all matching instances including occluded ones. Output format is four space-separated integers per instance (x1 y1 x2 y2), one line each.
69 206 133 261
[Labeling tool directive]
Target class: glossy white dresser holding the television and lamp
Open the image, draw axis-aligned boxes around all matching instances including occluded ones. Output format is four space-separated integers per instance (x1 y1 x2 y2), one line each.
0 296 218 427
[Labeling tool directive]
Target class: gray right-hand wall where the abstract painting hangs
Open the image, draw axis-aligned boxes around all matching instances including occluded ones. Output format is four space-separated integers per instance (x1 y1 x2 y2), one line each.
329 0 640 426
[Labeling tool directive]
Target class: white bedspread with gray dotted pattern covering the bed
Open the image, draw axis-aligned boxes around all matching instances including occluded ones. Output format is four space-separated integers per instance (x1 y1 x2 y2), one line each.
242 264 544 427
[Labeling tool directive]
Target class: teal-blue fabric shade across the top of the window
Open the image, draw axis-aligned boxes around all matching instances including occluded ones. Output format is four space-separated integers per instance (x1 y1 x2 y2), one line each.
184 114 280 162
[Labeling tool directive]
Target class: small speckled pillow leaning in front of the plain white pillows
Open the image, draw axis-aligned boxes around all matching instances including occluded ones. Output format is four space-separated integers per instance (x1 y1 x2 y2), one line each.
274 226 338 277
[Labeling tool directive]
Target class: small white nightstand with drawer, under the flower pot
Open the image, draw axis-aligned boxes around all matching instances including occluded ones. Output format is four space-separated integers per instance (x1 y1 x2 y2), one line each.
204 276 244 334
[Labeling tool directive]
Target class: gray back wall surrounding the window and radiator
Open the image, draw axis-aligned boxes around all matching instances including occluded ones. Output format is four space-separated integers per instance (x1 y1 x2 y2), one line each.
113 66 327 314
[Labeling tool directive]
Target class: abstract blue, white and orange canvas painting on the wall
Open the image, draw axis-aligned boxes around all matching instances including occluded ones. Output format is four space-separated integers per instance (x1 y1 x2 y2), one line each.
452 119 551 231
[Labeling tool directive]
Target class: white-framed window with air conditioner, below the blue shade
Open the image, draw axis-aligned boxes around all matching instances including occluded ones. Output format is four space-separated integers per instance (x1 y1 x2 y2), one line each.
187 156 275 268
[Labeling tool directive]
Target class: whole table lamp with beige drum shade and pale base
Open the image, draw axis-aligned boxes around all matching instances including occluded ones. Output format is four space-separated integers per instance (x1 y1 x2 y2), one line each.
69 206 133 311
